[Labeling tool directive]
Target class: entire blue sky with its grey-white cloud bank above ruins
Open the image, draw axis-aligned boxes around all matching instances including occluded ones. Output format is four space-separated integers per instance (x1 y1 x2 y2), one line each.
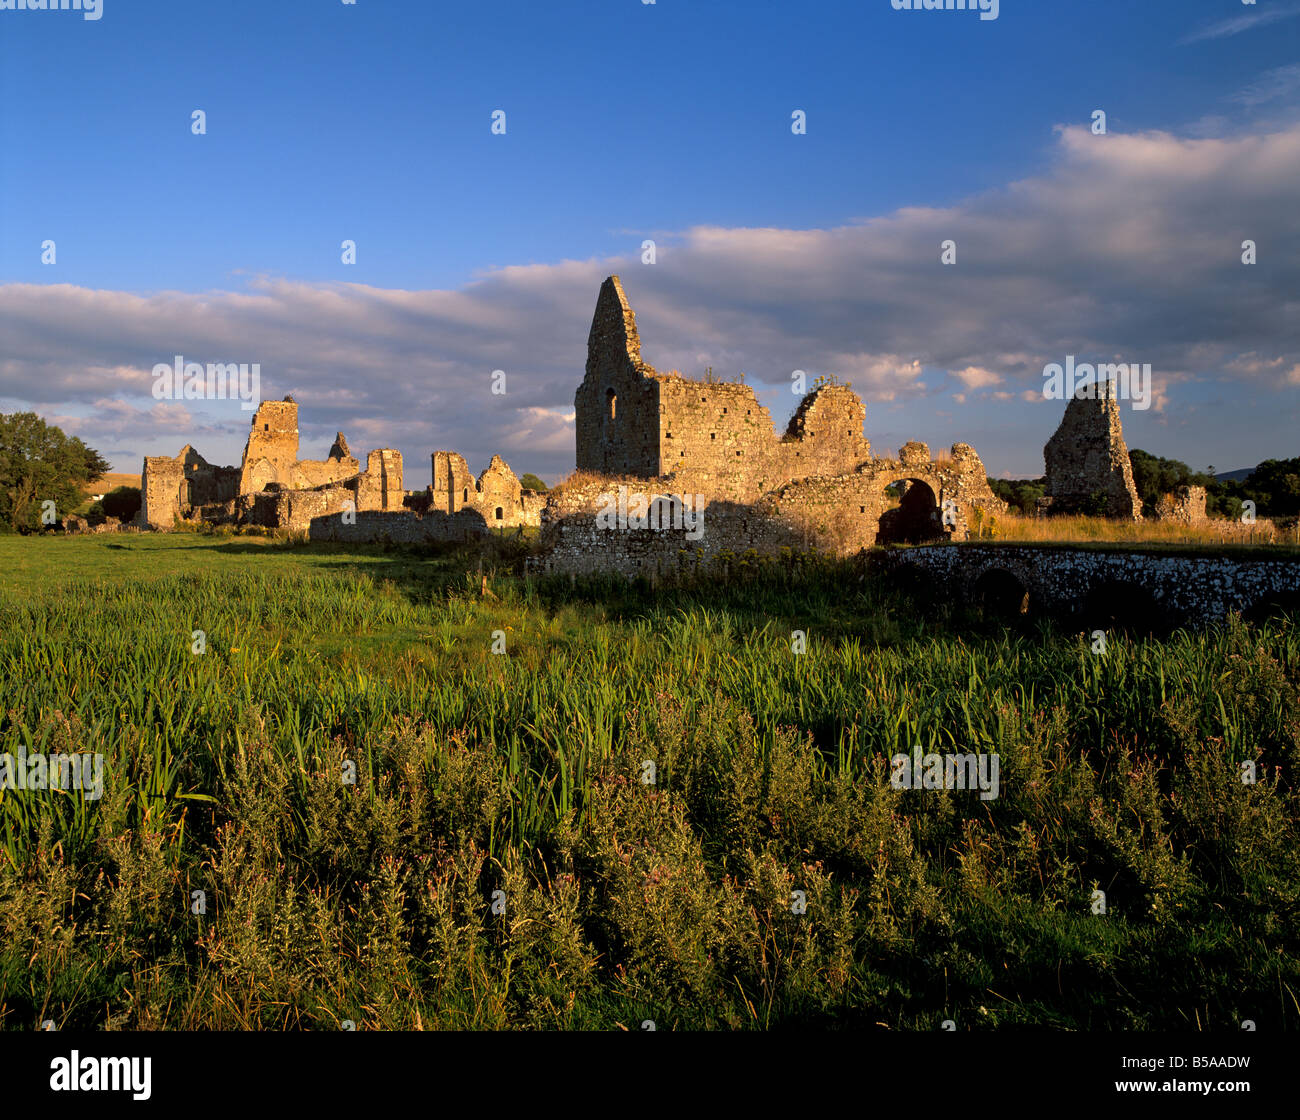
0 0 1300 487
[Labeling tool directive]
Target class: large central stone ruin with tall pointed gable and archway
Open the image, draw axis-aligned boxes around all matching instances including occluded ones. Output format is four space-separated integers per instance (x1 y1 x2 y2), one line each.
536 277 1006 574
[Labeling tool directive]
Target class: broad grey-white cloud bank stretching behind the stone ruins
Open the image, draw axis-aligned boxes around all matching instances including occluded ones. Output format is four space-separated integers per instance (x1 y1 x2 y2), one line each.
0 126 1300 486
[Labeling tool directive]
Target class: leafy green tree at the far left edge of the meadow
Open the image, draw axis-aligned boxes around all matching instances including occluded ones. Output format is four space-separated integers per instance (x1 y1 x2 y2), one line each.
0 412 108 531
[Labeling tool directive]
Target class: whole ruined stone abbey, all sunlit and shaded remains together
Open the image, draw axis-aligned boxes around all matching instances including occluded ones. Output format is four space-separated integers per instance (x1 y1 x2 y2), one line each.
139 270 1204 576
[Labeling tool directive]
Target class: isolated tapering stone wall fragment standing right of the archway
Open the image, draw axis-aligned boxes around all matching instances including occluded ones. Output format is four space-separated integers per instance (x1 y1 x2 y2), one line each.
1040 381 1141 521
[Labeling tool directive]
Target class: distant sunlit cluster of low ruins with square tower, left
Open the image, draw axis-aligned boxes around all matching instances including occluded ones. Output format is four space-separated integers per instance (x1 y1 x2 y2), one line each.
138 396 545 542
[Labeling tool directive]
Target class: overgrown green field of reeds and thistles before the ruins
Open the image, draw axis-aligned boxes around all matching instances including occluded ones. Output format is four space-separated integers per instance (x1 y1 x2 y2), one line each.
0 534 1300 1030
